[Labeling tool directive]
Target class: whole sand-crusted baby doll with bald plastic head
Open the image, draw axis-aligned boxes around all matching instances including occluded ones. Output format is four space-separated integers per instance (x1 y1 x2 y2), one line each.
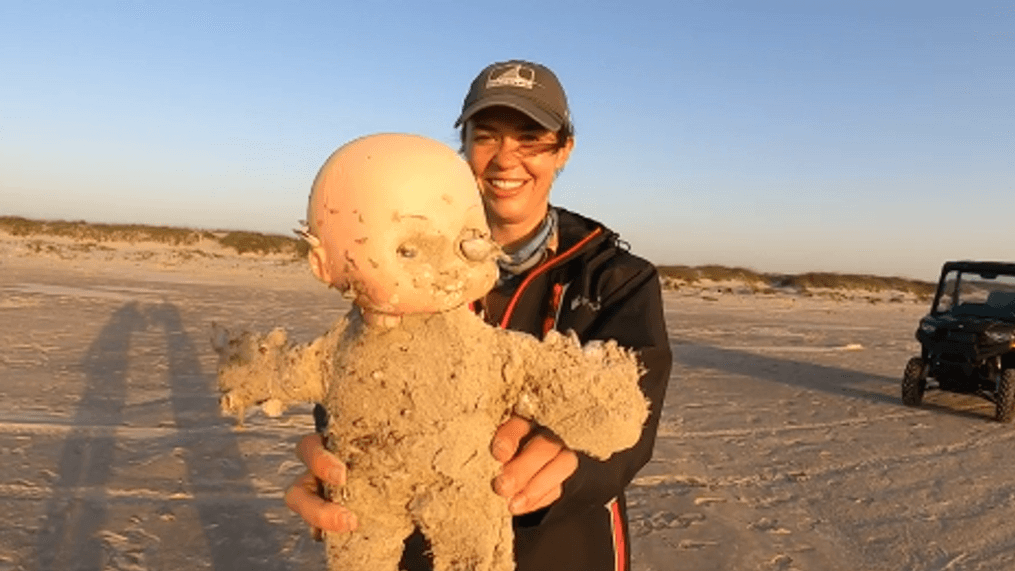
211 135 647 571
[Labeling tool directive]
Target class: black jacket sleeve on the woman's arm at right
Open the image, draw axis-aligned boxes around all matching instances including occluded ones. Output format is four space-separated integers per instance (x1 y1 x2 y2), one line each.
540 255 673 520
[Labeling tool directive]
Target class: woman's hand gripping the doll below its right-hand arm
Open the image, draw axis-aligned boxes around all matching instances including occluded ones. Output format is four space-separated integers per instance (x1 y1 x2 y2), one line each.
490 416 578 515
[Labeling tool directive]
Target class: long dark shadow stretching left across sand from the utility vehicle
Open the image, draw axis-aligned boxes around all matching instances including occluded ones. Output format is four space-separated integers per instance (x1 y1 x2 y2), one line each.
670 338 985 420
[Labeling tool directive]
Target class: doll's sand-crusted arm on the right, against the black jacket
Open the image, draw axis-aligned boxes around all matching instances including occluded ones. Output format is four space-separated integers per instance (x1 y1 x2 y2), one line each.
503 331 649 459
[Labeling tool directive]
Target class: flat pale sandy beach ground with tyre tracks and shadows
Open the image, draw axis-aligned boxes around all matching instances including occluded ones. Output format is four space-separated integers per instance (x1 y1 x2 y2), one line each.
0 233 1015 571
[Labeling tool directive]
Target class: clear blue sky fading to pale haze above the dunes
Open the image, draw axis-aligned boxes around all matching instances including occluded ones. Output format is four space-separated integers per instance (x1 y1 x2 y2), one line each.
0 0 1015 279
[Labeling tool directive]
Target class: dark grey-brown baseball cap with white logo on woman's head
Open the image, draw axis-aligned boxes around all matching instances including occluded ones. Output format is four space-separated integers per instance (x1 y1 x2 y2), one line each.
455 60 570 132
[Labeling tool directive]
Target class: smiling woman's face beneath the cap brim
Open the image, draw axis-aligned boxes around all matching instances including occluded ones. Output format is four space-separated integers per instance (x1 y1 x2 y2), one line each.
465 106 573 245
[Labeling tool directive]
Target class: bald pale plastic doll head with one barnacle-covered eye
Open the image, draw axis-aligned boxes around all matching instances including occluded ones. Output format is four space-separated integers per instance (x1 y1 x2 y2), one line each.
307 134 500 315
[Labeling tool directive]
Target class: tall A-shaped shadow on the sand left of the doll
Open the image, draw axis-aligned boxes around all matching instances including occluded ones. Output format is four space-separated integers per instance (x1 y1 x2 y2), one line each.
38 302 290 571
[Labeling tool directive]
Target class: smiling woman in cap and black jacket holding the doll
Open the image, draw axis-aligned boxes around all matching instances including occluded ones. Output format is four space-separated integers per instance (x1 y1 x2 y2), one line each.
286 61 672 571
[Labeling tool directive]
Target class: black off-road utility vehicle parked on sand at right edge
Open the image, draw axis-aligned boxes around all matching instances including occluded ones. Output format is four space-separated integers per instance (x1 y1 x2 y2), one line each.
902 262 1015 423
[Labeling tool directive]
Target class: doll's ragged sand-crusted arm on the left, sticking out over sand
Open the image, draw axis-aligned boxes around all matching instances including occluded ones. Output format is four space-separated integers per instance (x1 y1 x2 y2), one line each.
212 318 348 423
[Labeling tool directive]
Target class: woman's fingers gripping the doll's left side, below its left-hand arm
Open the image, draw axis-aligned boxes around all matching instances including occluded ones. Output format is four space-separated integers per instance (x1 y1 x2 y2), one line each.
285 433 356 540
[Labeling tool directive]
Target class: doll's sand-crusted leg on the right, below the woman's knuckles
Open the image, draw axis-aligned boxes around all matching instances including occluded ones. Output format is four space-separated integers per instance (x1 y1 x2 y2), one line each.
421 485 515 571
